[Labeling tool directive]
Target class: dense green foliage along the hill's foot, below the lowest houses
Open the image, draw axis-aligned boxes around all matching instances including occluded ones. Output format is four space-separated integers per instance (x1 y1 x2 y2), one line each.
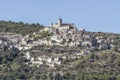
0 46 120 80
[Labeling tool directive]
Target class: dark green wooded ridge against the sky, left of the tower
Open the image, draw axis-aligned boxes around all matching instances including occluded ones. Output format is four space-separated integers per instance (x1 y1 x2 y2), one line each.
0 21 44 35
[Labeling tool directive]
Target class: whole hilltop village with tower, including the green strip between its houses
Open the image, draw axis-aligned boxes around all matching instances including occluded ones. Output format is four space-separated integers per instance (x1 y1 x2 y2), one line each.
0 18 120 79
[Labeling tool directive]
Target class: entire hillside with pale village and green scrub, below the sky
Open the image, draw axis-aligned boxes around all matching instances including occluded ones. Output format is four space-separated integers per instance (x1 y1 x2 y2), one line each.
0 21 120 80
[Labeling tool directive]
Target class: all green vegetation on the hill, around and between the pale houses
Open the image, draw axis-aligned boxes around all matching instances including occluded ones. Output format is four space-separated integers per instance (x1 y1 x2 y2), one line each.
0 21 120 80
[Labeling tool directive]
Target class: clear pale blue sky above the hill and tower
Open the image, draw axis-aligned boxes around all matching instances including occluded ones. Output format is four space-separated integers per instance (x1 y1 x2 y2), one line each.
0 0 120 33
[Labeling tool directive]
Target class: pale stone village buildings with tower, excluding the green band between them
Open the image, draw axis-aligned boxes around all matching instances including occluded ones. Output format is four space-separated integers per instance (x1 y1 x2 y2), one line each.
0 18 116 67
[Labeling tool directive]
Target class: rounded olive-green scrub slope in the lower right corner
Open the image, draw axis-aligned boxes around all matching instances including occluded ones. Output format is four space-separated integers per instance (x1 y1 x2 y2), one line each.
65 51 120 80
